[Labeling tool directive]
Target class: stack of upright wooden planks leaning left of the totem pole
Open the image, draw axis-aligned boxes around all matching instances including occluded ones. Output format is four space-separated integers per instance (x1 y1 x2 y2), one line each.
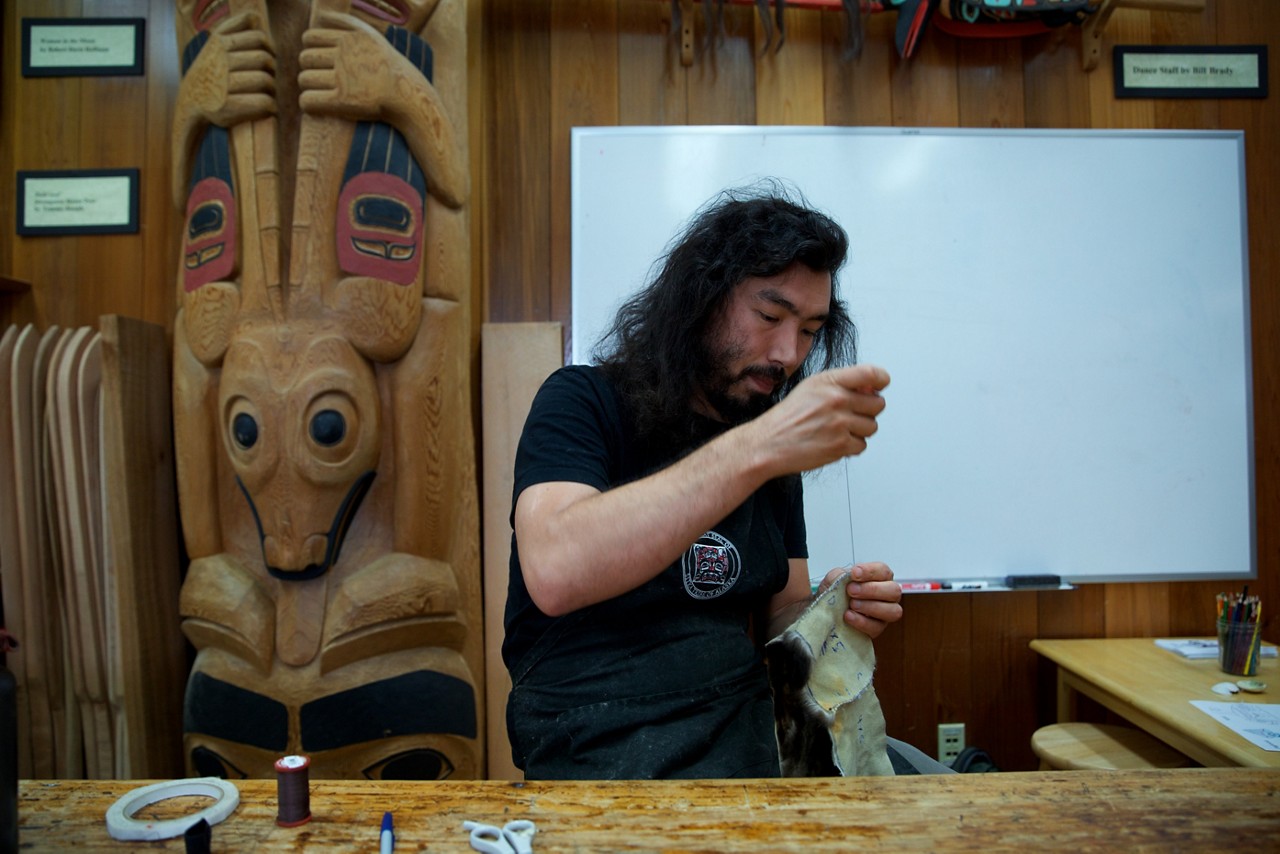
0 315 187 778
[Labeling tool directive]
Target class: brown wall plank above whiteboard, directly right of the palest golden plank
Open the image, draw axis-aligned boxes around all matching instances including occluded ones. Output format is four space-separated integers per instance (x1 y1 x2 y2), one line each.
822 12 897 127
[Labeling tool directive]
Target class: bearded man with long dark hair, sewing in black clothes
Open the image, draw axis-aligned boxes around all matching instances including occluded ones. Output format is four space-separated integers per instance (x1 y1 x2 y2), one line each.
503 184 902 778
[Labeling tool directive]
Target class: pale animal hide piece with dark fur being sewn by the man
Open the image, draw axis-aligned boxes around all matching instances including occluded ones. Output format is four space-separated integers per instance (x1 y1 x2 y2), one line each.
764 574 893 777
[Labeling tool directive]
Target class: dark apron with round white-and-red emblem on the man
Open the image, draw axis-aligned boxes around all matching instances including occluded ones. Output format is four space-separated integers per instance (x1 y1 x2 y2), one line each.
507 485 787 780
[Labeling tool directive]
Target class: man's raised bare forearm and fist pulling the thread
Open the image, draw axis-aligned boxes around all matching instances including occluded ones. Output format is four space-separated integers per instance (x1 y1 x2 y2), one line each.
516 365 888 616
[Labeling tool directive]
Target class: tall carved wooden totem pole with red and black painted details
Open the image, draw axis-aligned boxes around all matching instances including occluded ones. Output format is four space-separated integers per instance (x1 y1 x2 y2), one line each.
173 0 484 778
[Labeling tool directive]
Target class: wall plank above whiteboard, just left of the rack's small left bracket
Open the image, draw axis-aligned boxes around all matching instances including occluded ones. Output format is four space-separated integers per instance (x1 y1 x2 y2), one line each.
617 1 689 125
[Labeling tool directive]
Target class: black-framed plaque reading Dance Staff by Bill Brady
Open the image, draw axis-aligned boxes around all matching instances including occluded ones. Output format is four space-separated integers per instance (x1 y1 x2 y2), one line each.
1112 45 1267 97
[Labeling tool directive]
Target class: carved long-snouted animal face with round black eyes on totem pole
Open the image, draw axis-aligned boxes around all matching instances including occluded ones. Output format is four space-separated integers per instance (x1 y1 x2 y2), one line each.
219 324 380 581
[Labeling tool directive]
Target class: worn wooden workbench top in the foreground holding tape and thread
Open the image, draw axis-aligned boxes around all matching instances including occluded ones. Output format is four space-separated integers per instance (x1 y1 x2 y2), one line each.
18 768 1280 854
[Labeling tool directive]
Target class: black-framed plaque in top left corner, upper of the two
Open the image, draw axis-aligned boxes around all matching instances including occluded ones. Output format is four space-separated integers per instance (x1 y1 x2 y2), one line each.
22 18 146 77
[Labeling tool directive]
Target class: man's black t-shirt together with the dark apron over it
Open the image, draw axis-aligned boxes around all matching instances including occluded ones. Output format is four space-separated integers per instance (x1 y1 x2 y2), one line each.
502 366 806 778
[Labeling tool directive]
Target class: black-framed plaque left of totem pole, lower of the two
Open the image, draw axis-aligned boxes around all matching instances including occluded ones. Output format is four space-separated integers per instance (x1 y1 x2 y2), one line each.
17 169 138 236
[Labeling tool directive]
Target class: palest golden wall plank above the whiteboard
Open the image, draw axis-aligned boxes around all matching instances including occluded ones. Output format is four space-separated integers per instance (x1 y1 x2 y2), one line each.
755 9 824 124
